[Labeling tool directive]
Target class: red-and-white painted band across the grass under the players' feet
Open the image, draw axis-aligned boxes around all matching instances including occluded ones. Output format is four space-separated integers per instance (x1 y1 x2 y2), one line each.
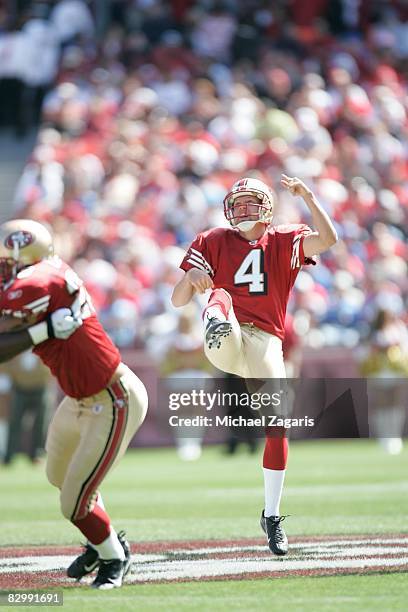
0 534 408 589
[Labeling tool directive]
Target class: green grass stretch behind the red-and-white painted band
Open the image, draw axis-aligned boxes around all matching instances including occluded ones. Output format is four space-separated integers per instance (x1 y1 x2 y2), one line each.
0 440 408 546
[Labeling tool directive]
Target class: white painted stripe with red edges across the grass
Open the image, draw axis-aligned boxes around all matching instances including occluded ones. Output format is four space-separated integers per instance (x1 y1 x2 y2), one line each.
0 537 408 582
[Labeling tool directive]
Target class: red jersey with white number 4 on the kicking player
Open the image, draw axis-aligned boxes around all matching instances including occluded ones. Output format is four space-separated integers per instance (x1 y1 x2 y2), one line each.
180 225 315 340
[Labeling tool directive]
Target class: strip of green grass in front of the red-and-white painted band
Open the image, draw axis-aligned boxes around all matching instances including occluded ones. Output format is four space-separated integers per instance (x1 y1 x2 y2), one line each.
57 574 408 612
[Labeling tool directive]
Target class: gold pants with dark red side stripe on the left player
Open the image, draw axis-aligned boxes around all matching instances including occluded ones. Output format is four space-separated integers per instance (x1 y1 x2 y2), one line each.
46 368 147 521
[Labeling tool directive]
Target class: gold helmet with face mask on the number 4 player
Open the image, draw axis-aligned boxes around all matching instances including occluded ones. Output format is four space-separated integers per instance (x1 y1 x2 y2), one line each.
224 178 274 231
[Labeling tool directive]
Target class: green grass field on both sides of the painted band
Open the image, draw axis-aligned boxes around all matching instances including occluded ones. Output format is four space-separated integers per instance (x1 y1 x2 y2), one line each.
0 440 408 611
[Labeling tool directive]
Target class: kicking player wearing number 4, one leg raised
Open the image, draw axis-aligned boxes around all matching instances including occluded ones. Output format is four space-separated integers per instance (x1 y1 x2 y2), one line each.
172 175 337 555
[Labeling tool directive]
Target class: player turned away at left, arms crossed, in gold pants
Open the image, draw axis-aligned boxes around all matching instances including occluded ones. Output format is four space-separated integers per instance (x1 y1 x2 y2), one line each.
0 219 147 589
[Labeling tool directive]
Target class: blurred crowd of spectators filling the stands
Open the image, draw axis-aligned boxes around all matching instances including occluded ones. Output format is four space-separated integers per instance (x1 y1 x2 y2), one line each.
0 0 408 370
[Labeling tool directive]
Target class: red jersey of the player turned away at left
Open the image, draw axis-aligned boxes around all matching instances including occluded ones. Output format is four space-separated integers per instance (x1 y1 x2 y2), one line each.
0 257 121 399
